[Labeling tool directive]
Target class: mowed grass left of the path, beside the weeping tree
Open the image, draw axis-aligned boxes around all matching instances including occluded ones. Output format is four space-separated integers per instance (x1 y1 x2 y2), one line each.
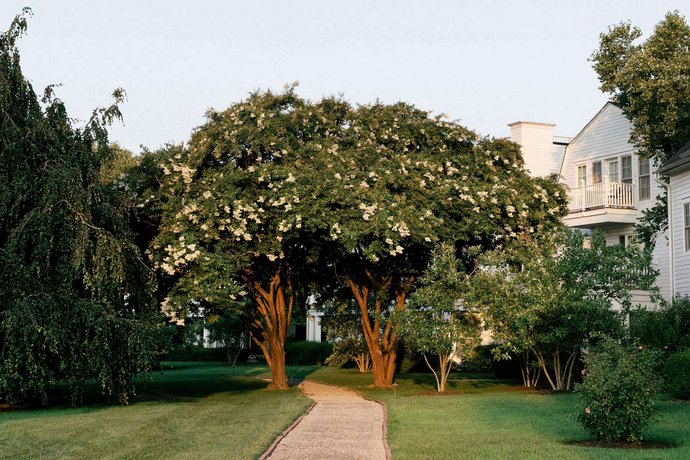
0 363 311 459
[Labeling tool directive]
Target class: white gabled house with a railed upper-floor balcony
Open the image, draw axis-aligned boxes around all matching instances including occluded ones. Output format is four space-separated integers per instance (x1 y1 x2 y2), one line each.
560 102 668 306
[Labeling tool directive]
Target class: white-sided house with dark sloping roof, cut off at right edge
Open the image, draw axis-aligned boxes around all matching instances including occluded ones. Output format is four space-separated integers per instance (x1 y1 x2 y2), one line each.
657 142 690 297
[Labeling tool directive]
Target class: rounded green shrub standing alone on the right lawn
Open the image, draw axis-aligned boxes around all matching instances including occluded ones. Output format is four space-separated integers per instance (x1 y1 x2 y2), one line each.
576 338 660 442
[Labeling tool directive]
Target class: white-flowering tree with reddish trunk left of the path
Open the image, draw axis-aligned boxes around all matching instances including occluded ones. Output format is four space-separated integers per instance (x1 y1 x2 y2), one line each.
152 87 346 389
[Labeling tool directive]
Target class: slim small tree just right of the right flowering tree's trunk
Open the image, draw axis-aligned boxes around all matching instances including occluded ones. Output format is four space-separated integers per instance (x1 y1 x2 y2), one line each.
400 243 481 392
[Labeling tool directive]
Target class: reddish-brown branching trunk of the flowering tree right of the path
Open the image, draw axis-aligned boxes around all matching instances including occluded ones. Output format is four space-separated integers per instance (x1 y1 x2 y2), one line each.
347 274 413 388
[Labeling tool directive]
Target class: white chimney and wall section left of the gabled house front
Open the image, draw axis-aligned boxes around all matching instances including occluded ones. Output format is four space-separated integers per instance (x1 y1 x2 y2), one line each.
508 121 571 177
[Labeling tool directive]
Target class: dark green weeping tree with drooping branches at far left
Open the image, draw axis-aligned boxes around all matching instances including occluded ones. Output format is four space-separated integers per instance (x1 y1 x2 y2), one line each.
0 9 156 404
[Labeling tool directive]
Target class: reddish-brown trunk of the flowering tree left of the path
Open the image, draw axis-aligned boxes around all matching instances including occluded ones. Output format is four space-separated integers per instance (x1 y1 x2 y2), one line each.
245 270 294 390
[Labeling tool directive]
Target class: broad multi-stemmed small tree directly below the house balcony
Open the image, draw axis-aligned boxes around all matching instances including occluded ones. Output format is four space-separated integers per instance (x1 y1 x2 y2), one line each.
468 230 657 390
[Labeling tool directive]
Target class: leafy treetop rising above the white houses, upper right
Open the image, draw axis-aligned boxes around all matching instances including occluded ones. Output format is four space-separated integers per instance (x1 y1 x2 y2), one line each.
592 11 690 162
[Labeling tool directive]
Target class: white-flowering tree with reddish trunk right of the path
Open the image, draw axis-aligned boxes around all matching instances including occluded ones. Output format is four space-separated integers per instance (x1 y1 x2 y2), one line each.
308 103 565 387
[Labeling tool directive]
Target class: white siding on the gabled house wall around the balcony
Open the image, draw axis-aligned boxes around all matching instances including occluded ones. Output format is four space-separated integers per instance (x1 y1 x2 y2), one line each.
560 103 668 305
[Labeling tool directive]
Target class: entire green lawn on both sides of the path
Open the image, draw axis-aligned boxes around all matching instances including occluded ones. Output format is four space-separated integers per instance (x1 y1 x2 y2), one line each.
0 363 690 459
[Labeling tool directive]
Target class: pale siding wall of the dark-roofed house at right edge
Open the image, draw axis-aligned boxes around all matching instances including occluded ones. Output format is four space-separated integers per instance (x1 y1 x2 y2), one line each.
670 171 690 296
